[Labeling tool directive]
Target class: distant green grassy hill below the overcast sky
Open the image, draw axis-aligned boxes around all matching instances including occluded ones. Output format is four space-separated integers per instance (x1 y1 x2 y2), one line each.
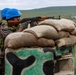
0 6 76 17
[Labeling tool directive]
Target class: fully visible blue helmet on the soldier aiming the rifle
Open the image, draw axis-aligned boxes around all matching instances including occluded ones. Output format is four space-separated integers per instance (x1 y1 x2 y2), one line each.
6 9 21 20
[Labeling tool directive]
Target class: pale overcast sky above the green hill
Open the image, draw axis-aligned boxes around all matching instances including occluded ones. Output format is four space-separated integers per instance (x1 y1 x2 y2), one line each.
0 0 76 10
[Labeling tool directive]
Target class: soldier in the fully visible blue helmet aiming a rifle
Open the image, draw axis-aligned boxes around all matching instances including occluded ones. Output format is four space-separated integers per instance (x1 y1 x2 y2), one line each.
6 9 26 32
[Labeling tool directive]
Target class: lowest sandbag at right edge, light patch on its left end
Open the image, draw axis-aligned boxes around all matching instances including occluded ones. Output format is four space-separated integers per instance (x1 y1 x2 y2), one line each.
56 36 76 47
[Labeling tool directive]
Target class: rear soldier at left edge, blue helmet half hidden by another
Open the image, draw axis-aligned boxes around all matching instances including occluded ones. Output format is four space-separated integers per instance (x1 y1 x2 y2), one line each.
0 8 10 75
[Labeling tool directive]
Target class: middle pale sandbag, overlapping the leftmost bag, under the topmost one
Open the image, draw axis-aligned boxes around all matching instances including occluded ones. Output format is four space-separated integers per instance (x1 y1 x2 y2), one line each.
23 25 62 39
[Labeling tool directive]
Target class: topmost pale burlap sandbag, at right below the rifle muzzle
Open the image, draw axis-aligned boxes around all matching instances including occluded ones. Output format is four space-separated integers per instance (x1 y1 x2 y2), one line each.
39 19 75 32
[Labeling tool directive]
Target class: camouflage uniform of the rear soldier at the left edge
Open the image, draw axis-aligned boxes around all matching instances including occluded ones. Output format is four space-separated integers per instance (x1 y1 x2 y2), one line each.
0 20 7 75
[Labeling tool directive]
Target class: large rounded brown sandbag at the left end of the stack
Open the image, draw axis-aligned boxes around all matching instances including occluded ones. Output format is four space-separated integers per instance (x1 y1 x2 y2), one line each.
4 32 37 49
